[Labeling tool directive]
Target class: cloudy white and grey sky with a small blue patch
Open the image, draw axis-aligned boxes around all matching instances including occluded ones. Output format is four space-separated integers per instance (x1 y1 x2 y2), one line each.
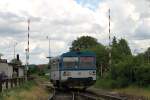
0 0 150 64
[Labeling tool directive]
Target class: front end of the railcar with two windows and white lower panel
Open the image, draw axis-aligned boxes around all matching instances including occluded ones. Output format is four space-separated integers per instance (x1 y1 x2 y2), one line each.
60 52 96 87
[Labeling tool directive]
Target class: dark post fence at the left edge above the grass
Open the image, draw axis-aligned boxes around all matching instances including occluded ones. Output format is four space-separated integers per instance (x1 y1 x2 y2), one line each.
0 77 25 92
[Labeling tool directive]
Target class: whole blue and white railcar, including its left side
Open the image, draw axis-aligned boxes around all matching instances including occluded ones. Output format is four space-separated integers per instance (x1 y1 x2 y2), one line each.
50 51 96 87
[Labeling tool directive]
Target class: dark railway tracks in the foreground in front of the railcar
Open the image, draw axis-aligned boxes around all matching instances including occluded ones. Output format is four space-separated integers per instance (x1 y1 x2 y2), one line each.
49 89 127 100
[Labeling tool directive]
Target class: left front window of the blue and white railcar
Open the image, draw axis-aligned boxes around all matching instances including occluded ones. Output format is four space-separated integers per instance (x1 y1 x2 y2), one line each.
63 57 78 68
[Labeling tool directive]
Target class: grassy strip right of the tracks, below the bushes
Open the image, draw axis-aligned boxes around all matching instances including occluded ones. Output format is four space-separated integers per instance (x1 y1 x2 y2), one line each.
94 79 150 97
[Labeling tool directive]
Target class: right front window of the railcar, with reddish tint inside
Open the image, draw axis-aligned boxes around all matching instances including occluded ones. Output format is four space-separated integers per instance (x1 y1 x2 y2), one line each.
79 57 95 68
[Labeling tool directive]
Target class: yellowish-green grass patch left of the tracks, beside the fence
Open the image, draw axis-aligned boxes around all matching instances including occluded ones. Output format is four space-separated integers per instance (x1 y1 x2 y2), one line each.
0 81 48 100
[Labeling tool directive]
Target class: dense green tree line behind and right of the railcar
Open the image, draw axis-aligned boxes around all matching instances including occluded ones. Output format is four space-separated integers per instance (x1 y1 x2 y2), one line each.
70 36 150 88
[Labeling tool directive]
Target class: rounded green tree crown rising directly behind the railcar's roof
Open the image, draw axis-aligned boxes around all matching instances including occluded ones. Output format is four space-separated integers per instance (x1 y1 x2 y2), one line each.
70 36 99 51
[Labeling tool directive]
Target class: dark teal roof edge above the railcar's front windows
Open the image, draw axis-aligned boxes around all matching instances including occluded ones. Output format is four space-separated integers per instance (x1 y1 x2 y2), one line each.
61 51 95 56
